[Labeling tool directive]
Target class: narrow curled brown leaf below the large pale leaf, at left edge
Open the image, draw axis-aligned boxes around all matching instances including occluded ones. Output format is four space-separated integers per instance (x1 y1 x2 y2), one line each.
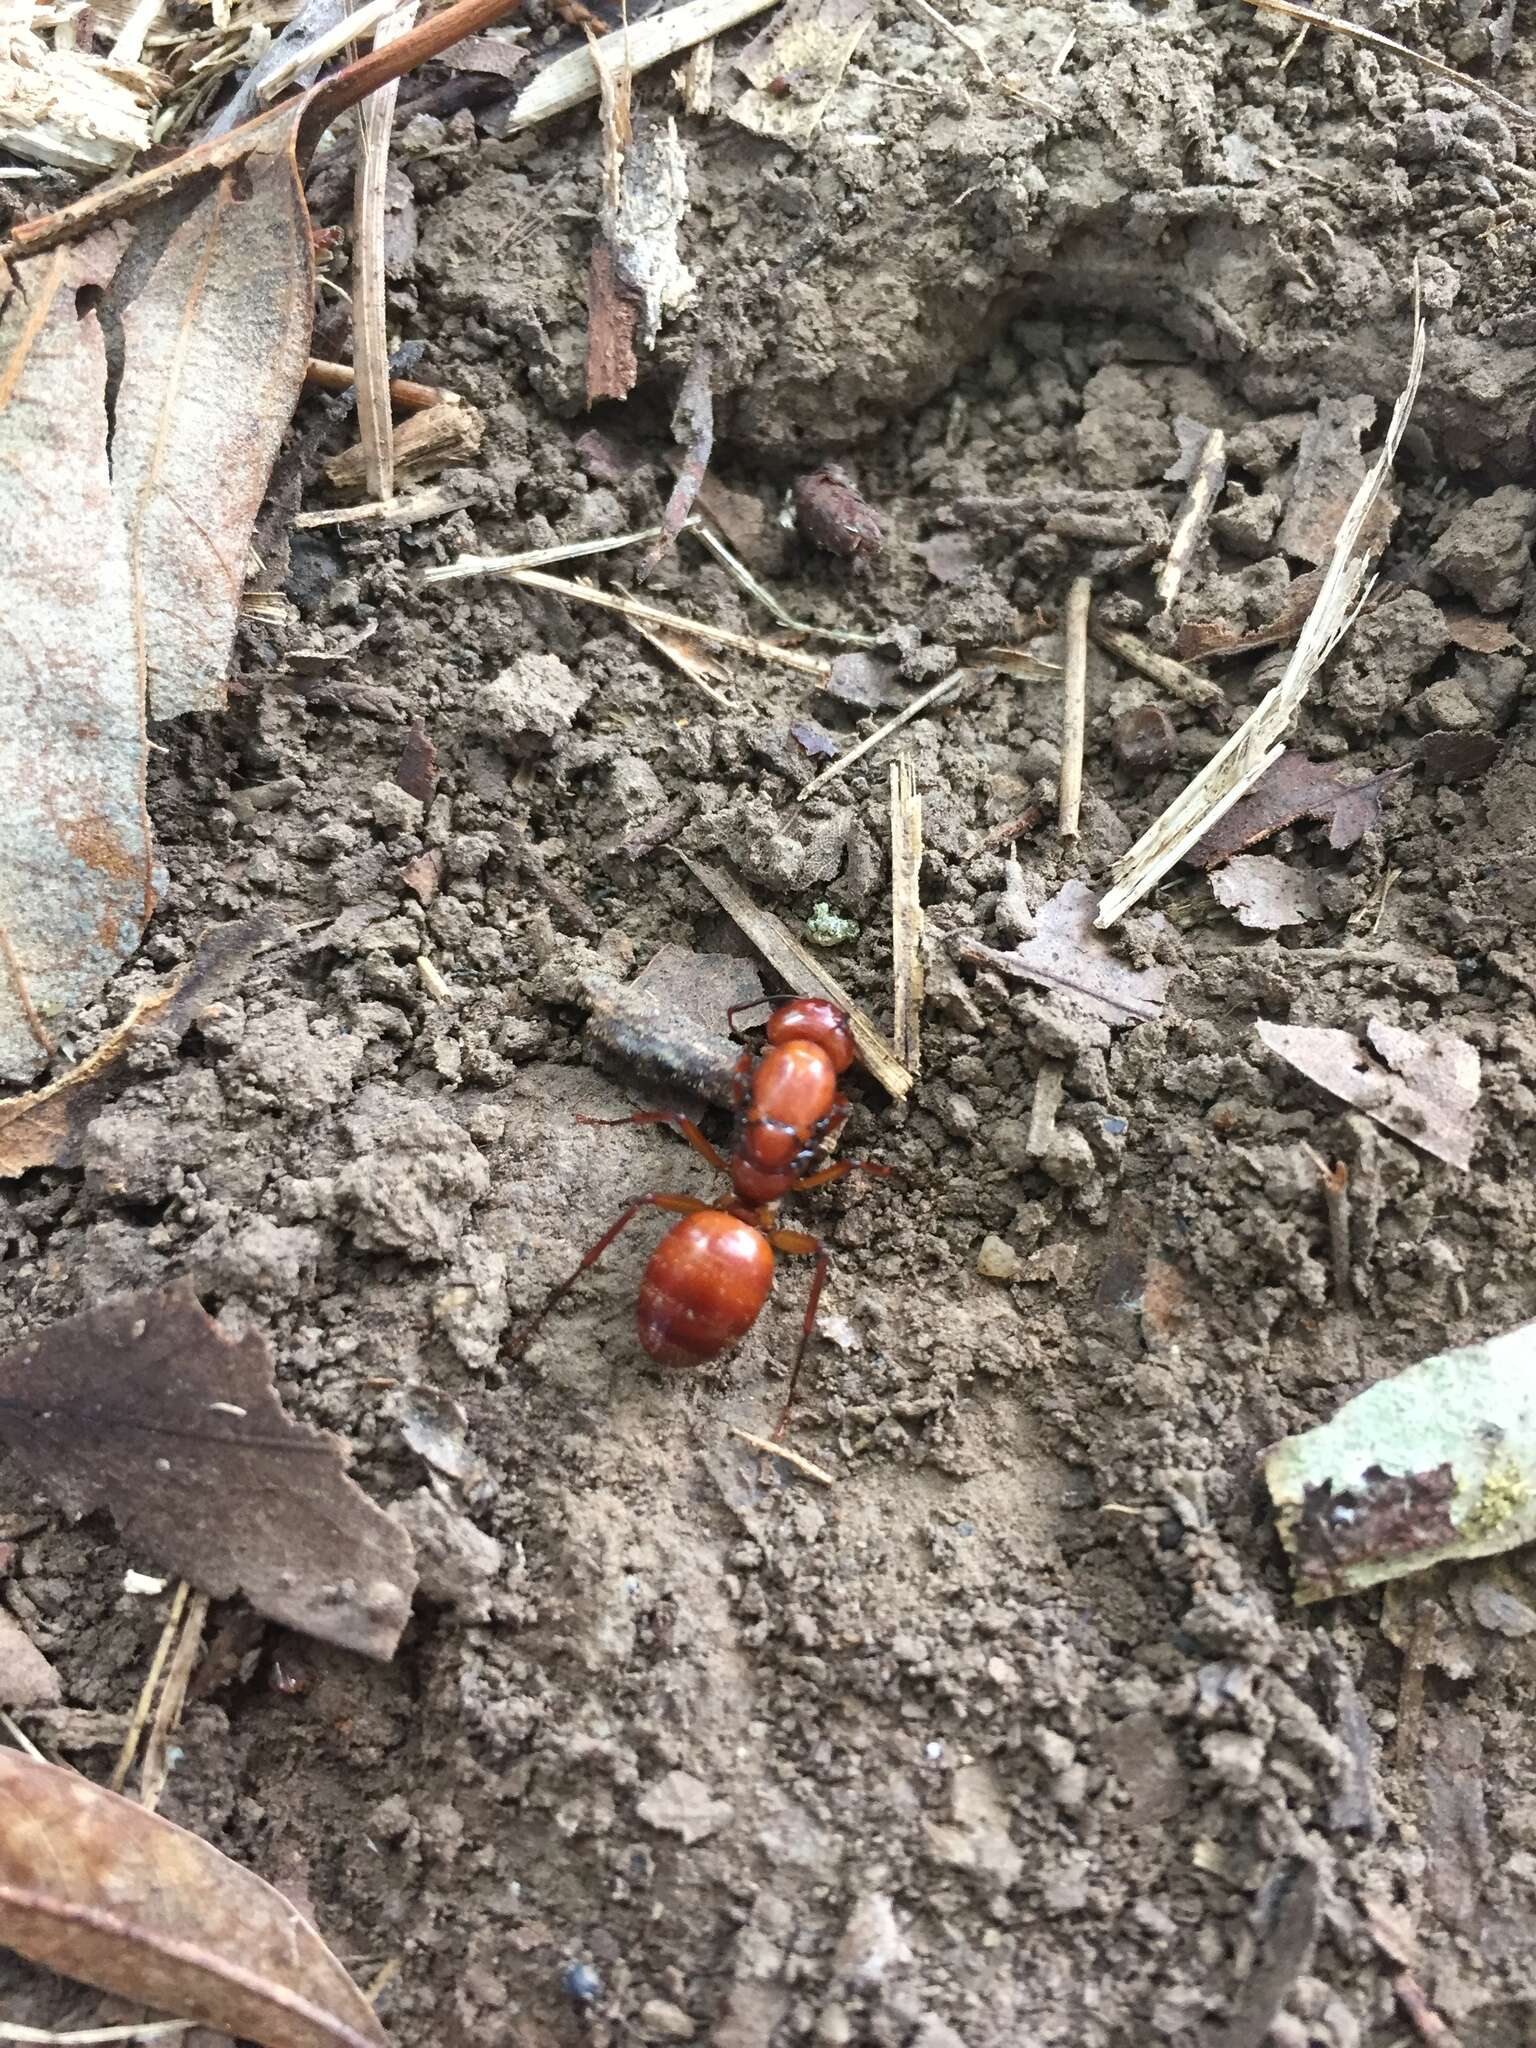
0 915 283 1180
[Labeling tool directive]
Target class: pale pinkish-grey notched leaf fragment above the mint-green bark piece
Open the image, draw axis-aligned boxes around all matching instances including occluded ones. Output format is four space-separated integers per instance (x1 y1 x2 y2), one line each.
1255 1018 1481 1171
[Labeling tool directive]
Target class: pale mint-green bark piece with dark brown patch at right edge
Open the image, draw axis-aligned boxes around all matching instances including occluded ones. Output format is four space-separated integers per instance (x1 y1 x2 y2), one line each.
1264 1323 1536 1602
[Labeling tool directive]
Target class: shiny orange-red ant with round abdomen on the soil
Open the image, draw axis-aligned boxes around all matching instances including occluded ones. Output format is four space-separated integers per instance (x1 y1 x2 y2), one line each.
514 995 891 1438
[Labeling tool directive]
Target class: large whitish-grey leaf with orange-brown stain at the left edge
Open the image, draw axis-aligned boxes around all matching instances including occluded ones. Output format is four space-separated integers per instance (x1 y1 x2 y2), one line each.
0 233 154 1081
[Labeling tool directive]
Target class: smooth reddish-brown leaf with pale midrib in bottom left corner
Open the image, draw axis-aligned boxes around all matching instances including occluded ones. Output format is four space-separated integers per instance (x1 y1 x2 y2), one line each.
0 1749 387 2048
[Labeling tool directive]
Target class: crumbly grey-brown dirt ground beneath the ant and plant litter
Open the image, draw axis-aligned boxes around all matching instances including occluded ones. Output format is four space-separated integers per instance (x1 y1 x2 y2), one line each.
0 0 1536 2048
